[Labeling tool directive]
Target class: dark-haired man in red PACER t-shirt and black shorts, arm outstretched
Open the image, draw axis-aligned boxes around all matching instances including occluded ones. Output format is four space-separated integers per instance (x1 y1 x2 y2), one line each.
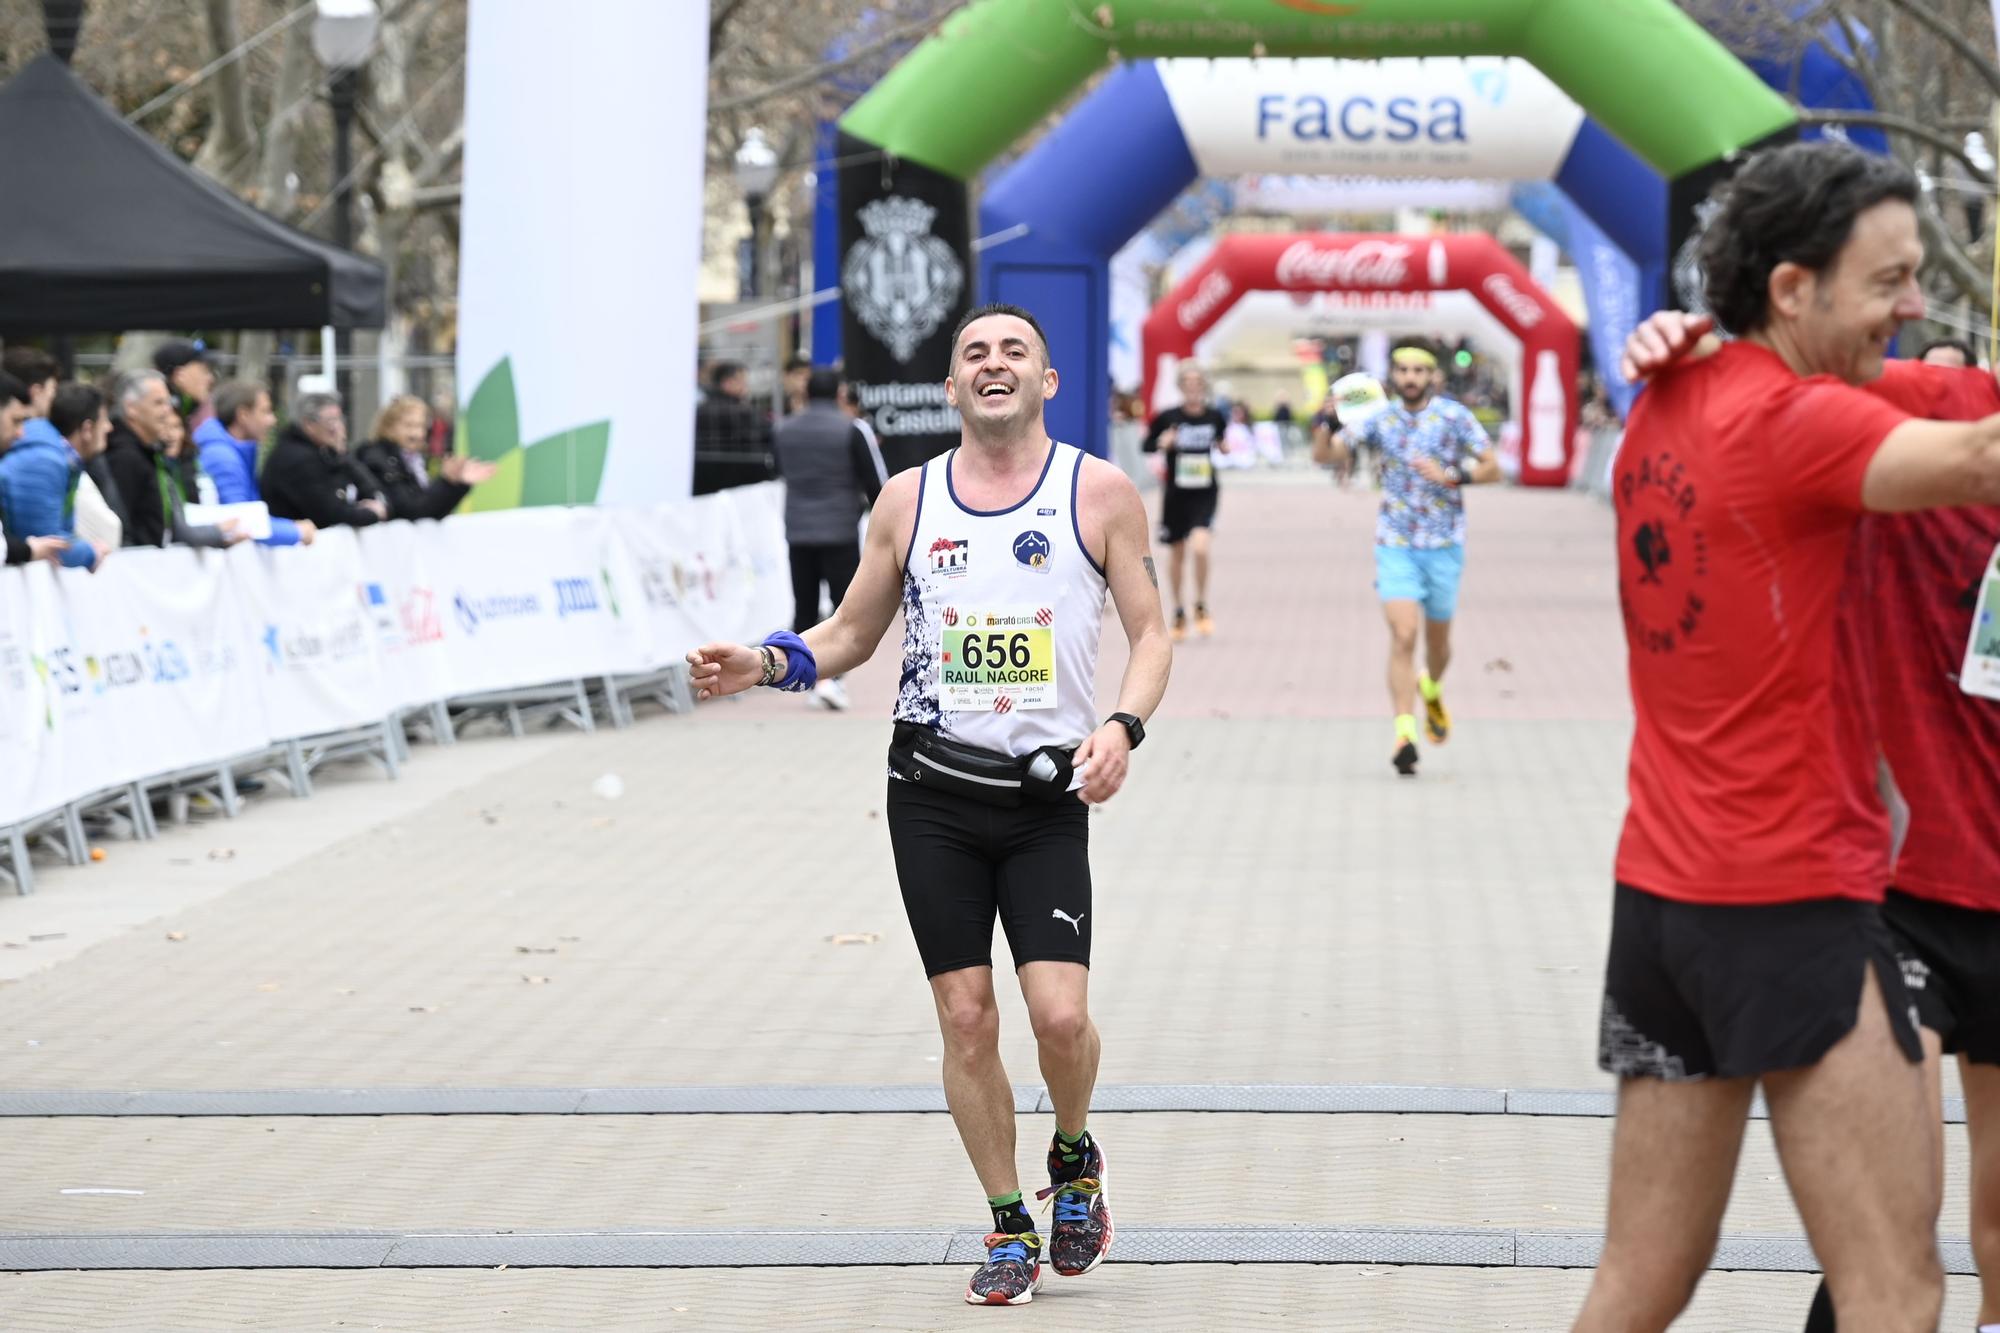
1576 142 2000 1329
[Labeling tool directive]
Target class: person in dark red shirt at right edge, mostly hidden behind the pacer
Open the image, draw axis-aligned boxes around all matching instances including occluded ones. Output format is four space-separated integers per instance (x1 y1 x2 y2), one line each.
1626 324 2000 1333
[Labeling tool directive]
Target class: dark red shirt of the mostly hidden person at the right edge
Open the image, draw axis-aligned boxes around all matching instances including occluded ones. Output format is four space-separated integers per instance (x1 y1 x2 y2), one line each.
1846 360 2000 911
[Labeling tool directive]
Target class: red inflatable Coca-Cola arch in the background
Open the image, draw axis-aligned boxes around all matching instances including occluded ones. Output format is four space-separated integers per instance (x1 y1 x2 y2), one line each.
1140 232 1578 486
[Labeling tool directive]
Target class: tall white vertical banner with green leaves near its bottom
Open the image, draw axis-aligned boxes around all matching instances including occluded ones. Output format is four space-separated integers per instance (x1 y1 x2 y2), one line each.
458 0 708 510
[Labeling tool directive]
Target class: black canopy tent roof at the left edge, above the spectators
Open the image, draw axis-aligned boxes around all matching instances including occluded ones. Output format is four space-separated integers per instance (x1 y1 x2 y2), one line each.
0 54 386 336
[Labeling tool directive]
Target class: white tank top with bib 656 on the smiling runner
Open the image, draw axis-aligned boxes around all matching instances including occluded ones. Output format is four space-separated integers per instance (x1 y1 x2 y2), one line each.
896 442 1106 759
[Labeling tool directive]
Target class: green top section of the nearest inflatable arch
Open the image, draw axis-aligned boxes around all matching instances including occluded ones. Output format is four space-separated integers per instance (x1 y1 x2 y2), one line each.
840 0 1798 180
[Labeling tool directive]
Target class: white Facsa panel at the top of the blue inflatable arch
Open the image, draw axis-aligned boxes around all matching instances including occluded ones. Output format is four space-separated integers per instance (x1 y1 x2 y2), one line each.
1158 56 1584 180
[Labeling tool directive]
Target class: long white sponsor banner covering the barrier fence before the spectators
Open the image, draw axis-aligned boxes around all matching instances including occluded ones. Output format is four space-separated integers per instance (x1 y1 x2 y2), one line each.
0 482 792 829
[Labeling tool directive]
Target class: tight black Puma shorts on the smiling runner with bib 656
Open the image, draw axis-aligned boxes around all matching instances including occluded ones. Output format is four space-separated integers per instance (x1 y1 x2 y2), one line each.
888 779 1090 977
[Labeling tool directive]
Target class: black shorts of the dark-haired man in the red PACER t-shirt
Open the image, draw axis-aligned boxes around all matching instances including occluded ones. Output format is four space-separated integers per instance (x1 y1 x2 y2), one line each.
1598 885 1924 1083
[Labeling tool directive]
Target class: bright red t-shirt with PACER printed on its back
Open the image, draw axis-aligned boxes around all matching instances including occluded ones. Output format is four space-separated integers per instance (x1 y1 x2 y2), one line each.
1612 342 1908 905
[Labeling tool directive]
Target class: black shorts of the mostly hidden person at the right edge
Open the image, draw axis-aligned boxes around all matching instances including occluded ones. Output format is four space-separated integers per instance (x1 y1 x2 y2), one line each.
1882 889 2000 1065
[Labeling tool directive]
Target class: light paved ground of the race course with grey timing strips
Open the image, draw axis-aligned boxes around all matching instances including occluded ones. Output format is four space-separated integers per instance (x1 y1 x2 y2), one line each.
0 474 1974 1331
